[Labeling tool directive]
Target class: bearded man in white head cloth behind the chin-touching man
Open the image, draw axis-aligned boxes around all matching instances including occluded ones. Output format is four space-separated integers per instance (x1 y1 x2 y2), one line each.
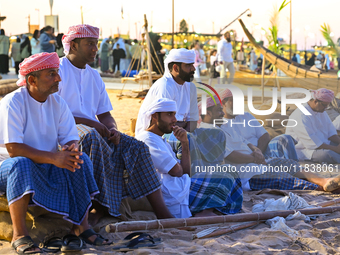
136 49 199 135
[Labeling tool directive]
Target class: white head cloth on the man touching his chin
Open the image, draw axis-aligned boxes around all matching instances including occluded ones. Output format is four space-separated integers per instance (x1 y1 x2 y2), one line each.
141 98 177 130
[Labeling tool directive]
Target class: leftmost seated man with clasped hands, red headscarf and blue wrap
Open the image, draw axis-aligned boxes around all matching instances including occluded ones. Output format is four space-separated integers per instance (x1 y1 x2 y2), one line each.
0 53 109 254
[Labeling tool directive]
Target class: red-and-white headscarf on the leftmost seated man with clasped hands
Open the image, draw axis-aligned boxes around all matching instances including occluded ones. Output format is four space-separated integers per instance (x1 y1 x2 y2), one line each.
17 52 59 86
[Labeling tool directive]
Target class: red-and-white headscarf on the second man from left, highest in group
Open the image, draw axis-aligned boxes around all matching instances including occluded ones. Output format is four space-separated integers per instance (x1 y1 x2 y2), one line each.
62 24 99 55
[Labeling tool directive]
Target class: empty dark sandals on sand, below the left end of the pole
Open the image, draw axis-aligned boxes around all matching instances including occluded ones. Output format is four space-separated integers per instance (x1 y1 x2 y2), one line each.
112 232 162 252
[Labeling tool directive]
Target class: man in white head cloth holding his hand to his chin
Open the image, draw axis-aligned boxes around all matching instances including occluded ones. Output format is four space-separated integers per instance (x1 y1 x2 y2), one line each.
136 98 191 218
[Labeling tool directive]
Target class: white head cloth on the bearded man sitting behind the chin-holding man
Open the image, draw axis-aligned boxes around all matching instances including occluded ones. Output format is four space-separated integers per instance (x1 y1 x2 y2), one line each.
164 48 196 75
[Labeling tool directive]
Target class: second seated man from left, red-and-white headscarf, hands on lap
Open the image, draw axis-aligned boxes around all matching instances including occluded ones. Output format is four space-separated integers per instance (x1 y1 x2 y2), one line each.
59 25 173 224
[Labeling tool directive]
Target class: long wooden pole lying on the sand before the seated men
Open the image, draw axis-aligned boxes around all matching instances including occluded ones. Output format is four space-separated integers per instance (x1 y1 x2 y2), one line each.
105 206 340 233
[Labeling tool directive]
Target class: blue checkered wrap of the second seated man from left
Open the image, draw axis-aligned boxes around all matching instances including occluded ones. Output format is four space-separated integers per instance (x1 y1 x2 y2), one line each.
77 125 161 216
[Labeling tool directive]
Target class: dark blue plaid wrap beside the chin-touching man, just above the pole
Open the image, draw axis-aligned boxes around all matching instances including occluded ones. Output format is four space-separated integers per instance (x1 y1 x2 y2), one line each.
189 173 243 214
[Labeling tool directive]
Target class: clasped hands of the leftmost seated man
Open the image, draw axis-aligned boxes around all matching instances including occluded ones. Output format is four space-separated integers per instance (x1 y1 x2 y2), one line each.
53 147 84 172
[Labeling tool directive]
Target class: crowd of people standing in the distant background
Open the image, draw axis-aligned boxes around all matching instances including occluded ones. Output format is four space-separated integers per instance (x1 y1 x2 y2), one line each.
0 26 340 78
